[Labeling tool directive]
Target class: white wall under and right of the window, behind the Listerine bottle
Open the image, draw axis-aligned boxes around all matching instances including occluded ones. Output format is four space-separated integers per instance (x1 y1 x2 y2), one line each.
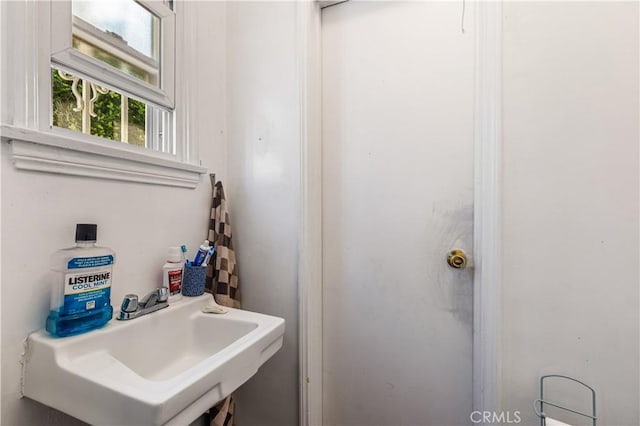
0 2 226 426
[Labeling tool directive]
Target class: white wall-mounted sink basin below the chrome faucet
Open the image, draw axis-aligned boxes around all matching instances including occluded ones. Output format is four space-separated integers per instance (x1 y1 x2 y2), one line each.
23 294 284 425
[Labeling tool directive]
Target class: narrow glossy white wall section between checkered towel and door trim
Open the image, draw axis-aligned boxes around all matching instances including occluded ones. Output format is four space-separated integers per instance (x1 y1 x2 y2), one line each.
227 2 300 426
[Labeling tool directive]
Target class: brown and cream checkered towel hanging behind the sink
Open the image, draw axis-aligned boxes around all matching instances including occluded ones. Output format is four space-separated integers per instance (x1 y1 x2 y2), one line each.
206 174 240 426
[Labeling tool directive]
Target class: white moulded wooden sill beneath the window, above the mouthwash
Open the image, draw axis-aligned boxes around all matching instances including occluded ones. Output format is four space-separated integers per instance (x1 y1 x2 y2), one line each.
0 125 207 188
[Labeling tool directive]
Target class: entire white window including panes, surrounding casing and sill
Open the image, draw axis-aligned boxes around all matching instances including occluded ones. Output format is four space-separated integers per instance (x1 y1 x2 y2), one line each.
0 0 207 188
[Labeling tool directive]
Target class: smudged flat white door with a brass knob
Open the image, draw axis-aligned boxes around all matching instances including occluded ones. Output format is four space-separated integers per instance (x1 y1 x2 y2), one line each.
322 1 474 426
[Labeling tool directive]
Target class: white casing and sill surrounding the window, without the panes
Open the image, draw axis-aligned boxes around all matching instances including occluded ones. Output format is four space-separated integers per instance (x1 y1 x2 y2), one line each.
0 0 207 188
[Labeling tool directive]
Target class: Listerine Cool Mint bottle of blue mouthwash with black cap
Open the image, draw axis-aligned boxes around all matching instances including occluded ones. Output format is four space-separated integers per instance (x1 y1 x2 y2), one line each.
46 224 115 337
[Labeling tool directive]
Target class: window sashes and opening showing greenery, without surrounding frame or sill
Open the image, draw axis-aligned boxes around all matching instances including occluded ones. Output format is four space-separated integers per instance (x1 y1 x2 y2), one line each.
51 0 176 154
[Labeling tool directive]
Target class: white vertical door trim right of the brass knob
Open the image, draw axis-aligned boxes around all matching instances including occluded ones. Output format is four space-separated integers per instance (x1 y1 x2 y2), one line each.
473 2 502 420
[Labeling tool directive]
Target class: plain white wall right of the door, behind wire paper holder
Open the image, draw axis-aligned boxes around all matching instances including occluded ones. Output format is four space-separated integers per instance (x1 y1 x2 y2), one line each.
502 2 640 425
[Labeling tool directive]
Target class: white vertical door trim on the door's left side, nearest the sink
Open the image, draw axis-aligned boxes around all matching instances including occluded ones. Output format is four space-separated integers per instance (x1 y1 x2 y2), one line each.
296 2 322 426
